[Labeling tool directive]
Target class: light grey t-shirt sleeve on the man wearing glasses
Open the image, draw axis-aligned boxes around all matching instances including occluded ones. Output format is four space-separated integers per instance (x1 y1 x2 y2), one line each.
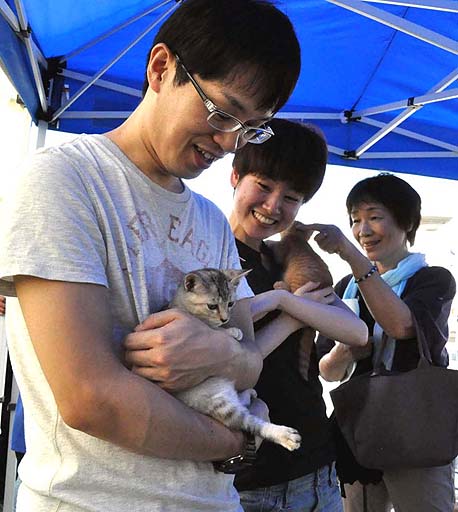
0 148 107 295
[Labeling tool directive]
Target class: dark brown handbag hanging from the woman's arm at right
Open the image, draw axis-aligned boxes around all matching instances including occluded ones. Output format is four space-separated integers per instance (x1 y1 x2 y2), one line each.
331 318 458 470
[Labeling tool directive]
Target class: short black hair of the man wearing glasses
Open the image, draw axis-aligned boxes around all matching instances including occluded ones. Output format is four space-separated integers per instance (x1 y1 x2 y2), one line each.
143 0 300 112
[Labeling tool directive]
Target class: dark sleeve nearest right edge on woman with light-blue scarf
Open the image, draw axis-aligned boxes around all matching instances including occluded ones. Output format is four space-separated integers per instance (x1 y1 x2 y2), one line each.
398 267 456 366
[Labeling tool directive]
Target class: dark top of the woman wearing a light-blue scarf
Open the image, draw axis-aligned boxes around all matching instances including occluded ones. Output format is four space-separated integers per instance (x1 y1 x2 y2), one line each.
317 267 456 484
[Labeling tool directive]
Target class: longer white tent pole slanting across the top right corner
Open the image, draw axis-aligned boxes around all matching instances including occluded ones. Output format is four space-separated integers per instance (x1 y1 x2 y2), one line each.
326 0 458 55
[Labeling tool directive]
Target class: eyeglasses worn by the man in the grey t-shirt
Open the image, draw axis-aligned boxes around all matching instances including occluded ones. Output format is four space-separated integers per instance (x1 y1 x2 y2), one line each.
175 54 274 149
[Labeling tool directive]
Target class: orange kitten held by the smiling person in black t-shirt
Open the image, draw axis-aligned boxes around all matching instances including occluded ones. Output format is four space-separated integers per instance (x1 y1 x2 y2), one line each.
269 221 332 380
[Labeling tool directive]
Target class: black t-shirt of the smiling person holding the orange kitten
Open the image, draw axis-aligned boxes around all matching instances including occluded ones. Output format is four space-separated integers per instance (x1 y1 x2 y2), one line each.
235 240 335 491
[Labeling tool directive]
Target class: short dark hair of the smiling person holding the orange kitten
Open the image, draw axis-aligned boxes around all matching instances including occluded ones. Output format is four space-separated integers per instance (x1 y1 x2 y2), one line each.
232 118 328 202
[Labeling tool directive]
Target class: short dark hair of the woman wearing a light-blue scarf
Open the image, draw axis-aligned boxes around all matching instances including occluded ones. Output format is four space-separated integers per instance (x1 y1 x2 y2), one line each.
346 173 421 245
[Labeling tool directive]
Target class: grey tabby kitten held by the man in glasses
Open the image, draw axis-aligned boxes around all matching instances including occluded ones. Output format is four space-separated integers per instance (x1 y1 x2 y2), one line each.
170 269 301 451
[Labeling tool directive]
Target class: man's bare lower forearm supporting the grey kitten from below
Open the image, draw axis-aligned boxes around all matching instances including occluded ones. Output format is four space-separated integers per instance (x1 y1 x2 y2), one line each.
67 369 242 461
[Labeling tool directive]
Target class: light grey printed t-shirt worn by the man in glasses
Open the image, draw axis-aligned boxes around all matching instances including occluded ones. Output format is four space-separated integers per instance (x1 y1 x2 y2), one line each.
0 135 252 512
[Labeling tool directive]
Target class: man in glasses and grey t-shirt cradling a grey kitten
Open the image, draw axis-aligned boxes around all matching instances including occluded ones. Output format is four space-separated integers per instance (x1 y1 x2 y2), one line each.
0 0 300 512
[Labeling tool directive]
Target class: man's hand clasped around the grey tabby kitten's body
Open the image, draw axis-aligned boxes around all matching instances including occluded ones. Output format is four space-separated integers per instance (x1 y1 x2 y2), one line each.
124 309 240 391
